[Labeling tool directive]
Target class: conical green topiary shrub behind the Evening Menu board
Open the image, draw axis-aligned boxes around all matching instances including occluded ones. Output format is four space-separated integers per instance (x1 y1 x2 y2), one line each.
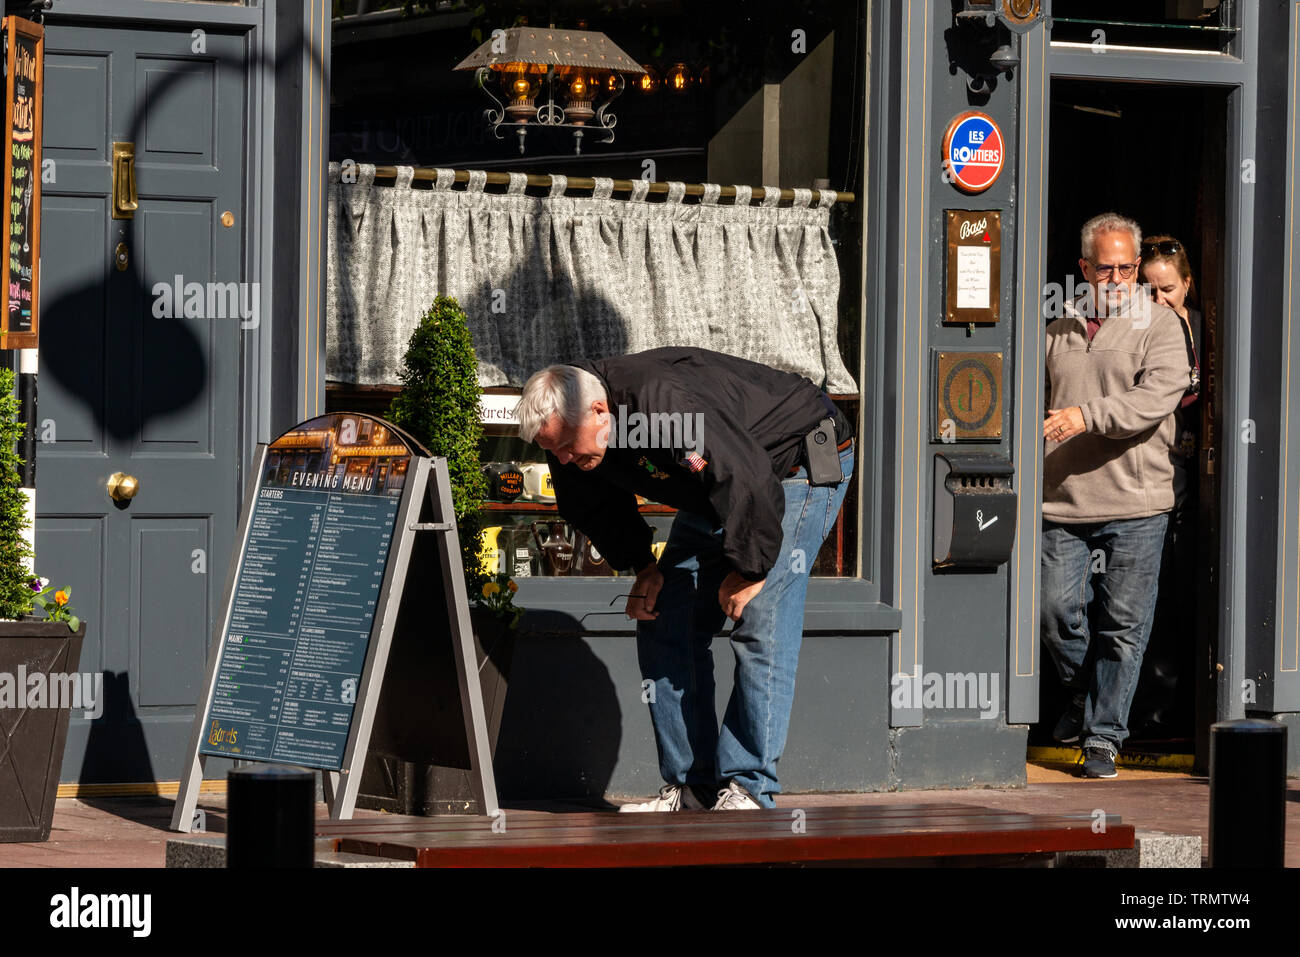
389 296 488 601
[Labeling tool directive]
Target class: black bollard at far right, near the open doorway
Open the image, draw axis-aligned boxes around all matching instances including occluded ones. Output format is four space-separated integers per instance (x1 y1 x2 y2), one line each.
1210 718 1287 867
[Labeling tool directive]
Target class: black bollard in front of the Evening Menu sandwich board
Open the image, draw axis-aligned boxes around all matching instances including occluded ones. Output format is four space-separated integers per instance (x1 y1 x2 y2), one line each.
226 765 316 869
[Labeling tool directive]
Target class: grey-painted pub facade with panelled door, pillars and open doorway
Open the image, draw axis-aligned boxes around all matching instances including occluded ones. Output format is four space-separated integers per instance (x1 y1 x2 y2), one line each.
7 0 1300 801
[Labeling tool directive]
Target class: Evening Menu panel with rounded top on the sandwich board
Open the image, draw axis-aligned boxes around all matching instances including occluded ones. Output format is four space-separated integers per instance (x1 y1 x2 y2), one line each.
199 413 417 771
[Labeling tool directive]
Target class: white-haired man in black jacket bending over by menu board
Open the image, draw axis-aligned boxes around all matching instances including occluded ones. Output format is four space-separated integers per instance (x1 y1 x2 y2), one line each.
516 347 853 811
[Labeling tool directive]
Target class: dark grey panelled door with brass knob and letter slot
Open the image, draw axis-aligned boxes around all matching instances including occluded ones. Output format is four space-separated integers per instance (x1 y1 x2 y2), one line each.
36 22 245 783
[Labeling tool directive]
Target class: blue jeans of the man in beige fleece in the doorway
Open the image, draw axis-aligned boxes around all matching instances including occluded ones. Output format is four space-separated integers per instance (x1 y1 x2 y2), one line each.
1040 512 1169 757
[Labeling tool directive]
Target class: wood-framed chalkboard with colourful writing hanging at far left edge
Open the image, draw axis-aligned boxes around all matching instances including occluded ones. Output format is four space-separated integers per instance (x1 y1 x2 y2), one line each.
0 17 46 348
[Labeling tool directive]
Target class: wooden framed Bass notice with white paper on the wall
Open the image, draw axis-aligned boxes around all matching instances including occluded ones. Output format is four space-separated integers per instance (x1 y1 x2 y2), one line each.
944 209 1002 325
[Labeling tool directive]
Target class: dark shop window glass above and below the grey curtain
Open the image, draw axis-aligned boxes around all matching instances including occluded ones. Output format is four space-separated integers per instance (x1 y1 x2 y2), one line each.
328 0 879 581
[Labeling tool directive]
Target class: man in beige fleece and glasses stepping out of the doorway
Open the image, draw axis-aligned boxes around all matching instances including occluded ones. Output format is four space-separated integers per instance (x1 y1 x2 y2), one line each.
1041 213 1191 778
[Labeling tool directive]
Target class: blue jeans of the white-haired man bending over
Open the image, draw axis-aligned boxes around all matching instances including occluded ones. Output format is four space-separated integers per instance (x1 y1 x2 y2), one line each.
637 446 853 807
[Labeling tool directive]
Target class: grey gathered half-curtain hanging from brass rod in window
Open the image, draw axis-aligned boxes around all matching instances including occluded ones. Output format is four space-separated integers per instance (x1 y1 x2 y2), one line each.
326 163 857 393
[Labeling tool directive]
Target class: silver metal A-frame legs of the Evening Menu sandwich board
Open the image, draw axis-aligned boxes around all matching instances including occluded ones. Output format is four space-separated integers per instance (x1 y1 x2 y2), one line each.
172 445 499 832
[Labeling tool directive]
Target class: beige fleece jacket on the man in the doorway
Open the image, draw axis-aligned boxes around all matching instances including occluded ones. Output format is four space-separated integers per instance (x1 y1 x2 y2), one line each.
1043 289 1191 524
